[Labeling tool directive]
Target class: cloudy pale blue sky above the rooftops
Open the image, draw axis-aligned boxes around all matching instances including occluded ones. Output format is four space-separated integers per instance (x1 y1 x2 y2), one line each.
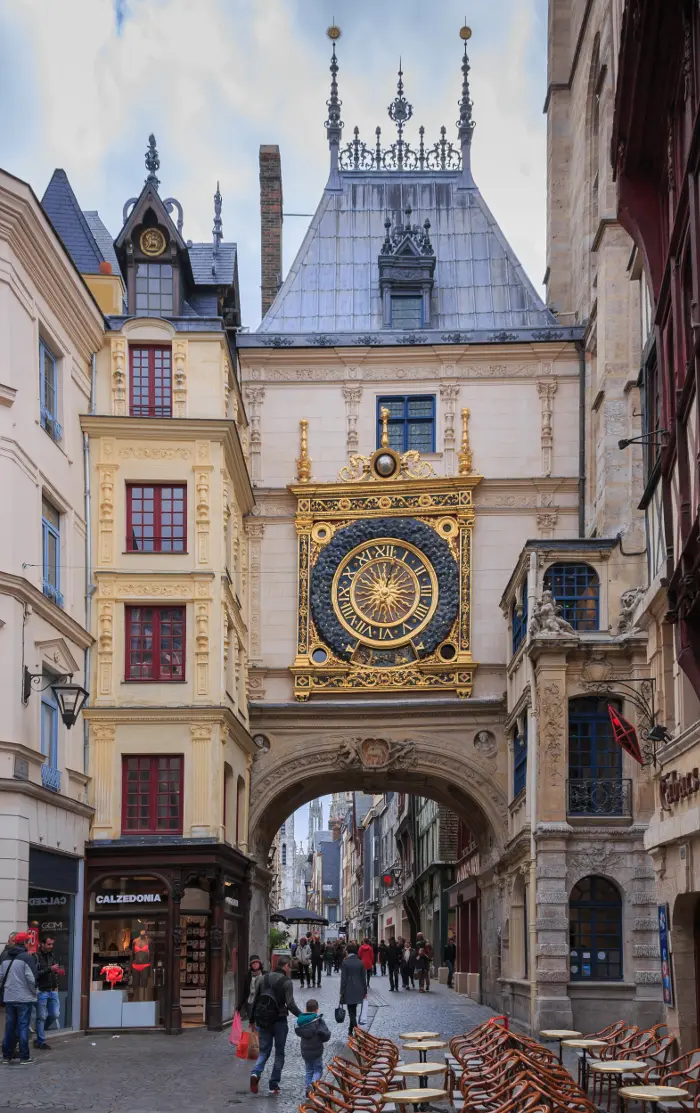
0 0 546 327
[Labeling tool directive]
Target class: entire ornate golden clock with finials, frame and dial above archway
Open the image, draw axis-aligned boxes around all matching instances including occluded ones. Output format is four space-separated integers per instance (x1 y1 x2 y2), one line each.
290 411 481 700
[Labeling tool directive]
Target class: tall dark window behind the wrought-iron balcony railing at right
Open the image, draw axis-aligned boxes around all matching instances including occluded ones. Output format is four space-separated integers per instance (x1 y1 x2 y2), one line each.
566 696 630 816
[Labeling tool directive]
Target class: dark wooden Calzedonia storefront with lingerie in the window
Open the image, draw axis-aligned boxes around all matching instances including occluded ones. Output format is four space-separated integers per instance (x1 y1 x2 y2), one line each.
81 844 248 1032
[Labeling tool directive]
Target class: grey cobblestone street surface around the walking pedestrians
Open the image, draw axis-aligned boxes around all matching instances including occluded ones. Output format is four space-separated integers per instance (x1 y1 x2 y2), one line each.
0 974 492 1113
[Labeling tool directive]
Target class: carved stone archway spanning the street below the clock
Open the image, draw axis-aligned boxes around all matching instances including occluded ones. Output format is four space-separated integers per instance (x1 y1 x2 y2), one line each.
249 726 507 953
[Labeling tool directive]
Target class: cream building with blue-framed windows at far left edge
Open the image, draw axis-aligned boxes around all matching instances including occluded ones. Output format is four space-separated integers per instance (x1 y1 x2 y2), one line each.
0 171 103 1026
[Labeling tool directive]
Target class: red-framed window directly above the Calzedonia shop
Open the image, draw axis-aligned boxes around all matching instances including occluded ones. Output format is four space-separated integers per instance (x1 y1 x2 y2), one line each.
121 756 184 835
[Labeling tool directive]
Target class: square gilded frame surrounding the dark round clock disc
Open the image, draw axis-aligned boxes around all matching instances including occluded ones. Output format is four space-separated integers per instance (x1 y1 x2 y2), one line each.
289 474 482 701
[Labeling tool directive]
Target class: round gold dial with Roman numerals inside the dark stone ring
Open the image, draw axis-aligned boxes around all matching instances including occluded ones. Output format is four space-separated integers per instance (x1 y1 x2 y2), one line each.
332 538 437 647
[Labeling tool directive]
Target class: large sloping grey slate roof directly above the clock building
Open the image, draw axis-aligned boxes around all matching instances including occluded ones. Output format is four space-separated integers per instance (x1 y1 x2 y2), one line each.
258 170 558 333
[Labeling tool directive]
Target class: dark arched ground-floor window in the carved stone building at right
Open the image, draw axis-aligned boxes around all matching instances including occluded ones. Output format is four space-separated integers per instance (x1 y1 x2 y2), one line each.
569 876 622 982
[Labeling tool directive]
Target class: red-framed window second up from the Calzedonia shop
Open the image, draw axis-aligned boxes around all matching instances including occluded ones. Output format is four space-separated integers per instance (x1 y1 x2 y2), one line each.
125 607 185 681
